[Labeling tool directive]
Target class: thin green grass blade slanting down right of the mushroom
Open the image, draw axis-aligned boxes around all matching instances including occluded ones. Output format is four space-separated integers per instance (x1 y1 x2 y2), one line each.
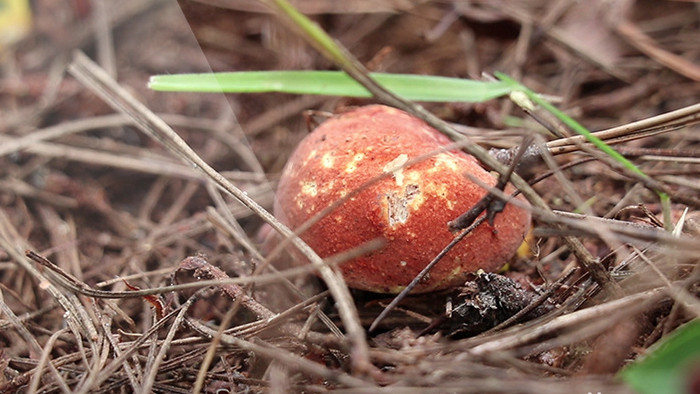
494 72 672 230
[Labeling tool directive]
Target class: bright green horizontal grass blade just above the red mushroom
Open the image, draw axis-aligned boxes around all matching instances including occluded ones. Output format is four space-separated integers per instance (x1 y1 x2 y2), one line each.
148 70 511 102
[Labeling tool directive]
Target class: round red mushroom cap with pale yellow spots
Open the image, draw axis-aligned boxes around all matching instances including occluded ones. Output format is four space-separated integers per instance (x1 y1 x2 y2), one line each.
274 105 530 293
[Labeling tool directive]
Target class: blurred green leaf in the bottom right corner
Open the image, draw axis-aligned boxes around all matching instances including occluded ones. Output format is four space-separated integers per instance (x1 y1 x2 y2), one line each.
619 319 700 394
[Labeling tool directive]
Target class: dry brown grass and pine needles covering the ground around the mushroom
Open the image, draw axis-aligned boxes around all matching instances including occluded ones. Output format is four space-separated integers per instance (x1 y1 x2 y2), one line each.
0 0 700 393
